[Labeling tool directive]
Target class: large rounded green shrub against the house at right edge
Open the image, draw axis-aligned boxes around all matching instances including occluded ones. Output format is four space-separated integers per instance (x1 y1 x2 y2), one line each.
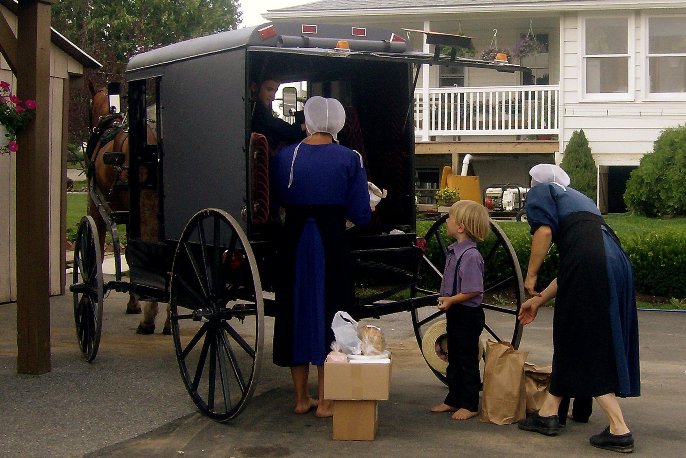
624 126 686 217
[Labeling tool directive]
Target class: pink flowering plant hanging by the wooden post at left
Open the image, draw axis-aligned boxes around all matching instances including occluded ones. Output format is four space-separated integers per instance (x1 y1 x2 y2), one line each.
0 81 36 154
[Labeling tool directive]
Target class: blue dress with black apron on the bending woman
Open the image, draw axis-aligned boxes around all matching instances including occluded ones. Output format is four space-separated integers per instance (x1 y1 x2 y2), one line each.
526 183 640 398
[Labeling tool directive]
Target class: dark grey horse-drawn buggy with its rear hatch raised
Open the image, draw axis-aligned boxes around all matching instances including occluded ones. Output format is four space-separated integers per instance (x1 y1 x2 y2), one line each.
71 22 524 421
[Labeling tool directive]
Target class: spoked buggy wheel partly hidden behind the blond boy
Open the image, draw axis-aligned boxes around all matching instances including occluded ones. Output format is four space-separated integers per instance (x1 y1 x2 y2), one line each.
411 214 524 382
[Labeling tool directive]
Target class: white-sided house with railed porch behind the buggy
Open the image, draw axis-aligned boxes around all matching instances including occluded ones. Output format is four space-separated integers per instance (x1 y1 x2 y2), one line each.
266 0 686 212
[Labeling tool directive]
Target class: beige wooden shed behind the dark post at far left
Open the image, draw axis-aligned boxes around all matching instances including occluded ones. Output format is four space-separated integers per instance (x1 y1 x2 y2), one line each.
0 0 100 303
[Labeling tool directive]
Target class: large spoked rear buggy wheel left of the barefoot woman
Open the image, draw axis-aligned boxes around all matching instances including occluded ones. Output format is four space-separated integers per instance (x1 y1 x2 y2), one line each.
170 209 264 421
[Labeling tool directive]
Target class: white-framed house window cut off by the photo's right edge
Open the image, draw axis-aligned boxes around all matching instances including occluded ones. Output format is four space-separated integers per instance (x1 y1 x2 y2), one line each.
647 16 686 95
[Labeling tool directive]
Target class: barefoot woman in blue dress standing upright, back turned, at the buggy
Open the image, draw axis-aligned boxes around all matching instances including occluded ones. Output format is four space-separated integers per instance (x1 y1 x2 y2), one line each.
270 96 371 417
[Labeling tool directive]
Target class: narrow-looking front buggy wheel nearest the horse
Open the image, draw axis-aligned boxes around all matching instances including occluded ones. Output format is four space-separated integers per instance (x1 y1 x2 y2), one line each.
69 216 104 362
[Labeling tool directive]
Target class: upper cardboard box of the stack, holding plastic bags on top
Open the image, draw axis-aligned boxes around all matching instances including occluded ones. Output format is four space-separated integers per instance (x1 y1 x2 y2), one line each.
324 359 391 401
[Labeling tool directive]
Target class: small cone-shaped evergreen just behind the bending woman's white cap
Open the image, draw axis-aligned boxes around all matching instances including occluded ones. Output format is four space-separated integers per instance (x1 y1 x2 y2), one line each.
560 130 598 201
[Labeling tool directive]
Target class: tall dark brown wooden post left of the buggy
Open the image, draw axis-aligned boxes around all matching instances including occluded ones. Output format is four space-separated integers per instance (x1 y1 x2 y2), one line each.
16 0 52 374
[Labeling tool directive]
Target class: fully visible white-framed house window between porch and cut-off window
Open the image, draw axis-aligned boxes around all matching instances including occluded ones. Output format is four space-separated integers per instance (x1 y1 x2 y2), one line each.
583 17 633 100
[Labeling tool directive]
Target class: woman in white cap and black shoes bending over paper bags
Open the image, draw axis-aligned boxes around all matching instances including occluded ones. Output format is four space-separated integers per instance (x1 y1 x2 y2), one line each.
519 164 640 452
